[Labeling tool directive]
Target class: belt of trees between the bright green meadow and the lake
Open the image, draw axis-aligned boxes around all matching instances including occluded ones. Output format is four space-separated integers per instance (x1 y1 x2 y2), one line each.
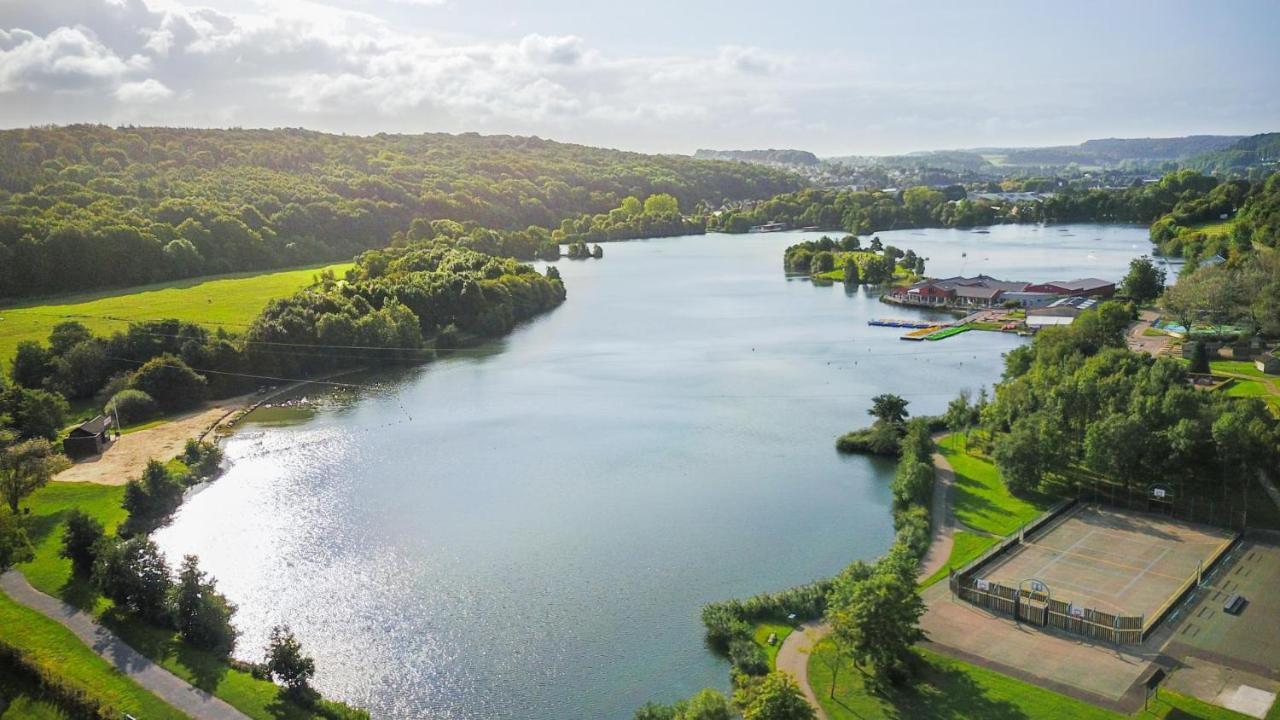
0 241 564 441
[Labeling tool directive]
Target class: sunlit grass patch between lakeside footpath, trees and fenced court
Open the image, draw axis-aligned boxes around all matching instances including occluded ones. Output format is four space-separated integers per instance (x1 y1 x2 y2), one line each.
938 434 1050 536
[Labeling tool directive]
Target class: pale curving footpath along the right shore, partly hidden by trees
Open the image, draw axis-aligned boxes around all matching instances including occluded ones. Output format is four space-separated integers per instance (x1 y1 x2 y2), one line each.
776 436 956 720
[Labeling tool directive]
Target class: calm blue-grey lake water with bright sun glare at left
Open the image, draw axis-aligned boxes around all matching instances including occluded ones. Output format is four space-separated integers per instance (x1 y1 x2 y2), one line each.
156 225 1151 720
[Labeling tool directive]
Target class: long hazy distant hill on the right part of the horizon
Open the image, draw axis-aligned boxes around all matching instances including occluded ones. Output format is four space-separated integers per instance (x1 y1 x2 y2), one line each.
983 135 1242 165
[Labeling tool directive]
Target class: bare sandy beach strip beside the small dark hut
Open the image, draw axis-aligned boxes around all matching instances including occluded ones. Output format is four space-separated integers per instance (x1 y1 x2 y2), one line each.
54 396 252 486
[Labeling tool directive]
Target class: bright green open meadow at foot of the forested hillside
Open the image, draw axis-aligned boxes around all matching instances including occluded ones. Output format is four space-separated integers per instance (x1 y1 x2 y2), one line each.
0 263 353 366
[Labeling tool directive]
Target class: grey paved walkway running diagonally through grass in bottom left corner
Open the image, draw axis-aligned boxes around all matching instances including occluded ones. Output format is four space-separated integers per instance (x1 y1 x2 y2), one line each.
0 570 248 720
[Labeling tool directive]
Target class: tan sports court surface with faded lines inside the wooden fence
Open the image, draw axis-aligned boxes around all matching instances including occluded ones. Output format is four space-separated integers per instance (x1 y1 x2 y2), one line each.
980 506 1233 621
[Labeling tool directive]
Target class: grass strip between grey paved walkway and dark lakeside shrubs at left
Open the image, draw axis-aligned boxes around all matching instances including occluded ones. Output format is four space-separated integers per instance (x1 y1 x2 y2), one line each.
10 476 368 720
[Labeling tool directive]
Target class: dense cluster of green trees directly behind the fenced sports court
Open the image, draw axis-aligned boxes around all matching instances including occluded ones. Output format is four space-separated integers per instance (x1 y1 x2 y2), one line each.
967 302 1280 497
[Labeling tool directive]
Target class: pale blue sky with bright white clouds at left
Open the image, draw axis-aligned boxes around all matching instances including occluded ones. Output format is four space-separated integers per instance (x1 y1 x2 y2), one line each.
0 0 1280 156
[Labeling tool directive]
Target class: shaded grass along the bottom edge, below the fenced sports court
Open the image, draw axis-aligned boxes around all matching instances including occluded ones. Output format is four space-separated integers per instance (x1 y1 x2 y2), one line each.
809 641 1259 720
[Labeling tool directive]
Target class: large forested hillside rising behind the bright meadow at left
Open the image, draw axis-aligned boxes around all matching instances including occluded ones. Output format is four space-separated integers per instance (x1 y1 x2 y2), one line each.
0 126 801 297
